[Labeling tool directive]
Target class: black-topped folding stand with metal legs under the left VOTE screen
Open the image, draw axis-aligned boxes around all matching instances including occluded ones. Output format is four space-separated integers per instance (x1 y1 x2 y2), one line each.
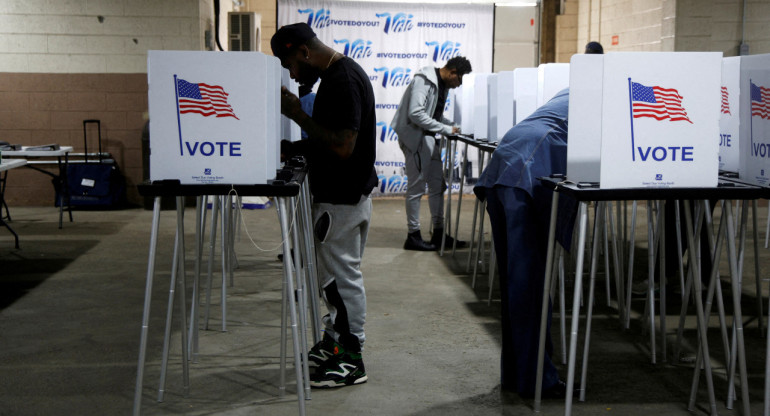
133 157 314 416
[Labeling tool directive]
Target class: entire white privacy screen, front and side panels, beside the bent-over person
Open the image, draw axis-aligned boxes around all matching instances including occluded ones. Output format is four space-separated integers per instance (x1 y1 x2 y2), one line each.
567 52 722 189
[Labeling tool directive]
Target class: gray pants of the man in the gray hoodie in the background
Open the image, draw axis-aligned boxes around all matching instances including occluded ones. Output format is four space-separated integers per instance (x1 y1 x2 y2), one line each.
401 136 447 233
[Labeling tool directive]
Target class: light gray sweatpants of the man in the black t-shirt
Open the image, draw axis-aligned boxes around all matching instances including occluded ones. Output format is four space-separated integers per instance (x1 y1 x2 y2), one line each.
313 196 372 352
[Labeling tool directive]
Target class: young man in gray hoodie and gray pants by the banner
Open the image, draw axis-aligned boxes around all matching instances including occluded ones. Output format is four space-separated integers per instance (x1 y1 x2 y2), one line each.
390 56 471 251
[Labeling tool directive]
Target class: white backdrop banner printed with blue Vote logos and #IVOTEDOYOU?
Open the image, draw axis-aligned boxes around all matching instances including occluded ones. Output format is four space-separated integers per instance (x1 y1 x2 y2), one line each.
278 0 494 194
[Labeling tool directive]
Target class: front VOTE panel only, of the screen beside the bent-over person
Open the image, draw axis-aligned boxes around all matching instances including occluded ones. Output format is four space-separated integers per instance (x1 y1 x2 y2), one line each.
600 52 722 188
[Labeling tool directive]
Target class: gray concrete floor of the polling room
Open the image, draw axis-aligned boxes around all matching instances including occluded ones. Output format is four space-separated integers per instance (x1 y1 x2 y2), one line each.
0 198 770 416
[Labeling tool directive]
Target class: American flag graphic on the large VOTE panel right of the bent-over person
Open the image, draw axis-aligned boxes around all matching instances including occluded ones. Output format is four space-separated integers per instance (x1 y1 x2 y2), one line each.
631 82 692 124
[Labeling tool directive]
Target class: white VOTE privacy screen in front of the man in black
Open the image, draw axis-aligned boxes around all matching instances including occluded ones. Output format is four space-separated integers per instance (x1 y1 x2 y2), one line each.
147 51 282 184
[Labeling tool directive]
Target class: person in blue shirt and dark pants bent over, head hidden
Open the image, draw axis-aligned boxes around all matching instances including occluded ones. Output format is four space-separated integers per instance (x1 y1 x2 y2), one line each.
474 90 574 398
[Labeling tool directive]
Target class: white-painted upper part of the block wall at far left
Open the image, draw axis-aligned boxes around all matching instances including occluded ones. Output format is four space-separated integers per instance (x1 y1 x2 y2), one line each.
0 0 232 73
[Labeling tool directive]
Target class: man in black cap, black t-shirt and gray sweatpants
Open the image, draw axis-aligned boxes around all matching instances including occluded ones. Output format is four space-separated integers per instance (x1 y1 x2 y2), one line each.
270 23 377 387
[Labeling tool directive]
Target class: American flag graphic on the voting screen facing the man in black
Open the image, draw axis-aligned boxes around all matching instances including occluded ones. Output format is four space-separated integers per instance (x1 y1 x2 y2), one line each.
177 78 240 120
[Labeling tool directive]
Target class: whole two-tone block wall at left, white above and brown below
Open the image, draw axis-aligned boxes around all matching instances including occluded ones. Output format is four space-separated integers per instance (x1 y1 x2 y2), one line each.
0 0 220 206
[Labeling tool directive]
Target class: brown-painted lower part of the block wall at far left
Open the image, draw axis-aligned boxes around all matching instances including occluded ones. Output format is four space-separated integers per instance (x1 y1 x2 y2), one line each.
0 73 147 207
